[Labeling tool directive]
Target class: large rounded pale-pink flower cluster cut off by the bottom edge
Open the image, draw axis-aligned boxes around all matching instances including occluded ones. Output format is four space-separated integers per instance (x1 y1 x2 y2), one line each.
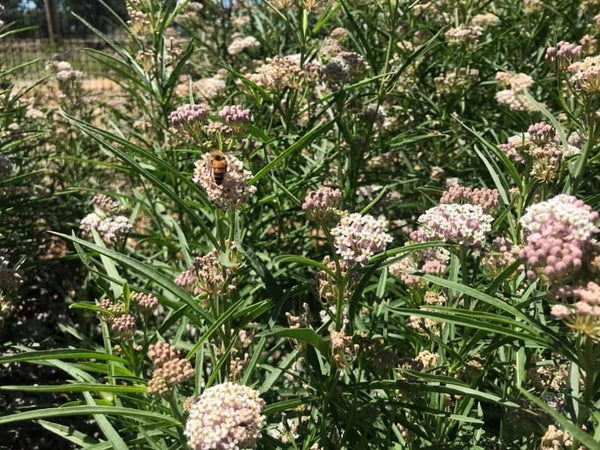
184 382 265 450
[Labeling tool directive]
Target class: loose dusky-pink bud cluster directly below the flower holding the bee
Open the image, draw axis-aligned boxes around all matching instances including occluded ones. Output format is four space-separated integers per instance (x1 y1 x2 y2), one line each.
175 247 236 306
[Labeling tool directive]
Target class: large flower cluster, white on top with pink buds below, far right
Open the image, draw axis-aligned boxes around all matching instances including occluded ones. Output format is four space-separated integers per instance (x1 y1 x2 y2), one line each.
519 194 599 284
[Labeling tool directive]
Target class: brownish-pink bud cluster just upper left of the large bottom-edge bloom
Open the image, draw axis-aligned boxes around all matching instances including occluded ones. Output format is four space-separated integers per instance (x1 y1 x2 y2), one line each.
148 342 196 397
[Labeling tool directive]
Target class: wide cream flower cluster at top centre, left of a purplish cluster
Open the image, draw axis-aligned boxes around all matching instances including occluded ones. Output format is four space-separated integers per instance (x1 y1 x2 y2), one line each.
246 55 319 92
